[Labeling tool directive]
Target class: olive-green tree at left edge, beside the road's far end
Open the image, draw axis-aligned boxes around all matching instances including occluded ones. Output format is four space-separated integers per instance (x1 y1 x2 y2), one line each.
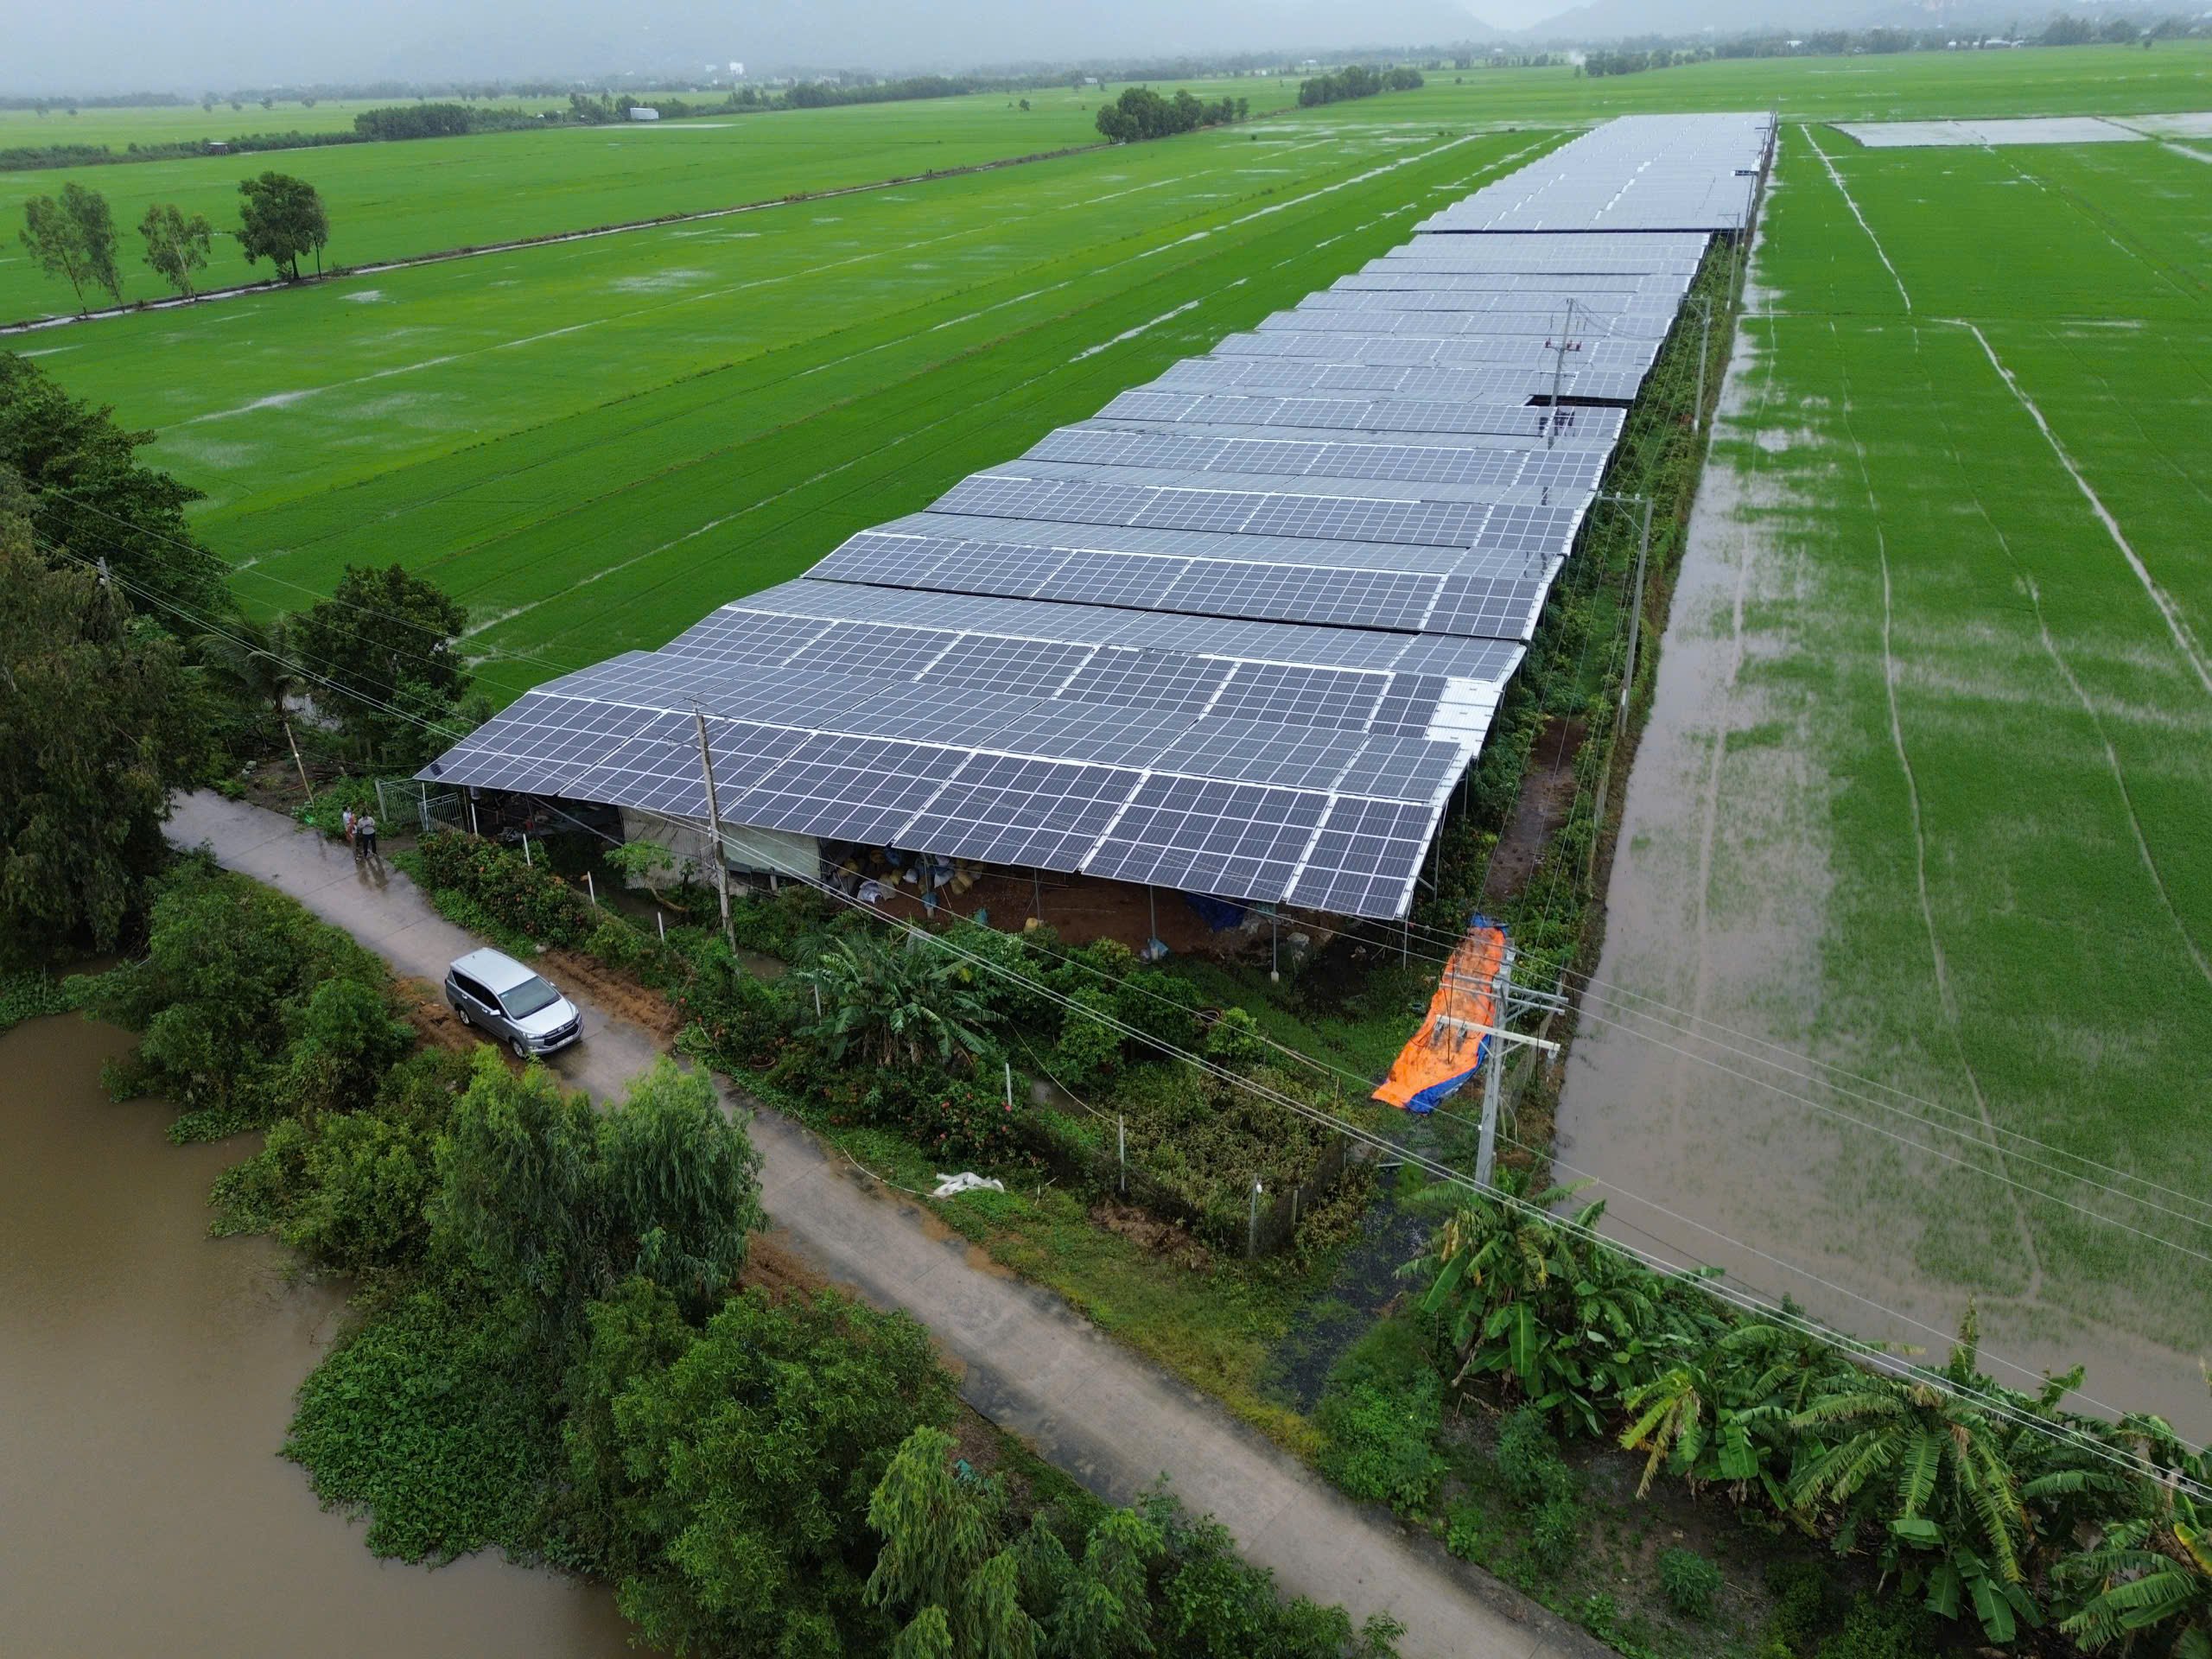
0 518 206 960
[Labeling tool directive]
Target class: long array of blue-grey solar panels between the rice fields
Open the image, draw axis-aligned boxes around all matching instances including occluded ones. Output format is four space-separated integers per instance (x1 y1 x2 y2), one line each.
425 115 1772 918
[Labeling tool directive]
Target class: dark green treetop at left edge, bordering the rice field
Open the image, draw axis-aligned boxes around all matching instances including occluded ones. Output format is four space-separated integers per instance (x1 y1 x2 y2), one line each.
0 352 230 619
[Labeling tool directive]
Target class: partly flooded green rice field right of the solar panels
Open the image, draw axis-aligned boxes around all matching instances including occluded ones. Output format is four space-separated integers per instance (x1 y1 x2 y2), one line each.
1561 126 2212 1425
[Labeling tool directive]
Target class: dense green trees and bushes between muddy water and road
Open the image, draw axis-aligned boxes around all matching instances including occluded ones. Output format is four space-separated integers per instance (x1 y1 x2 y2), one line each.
52 858 1391 1659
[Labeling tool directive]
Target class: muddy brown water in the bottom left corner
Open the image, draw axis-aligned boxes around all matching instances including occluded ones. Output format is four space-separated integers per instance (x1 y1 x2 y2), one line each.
0 1018 632 1659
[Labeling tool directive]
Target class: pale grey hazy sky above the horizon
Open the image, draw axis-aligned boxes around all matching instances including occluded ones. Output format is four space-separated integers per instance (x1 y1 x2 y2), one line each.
0 0 1601 93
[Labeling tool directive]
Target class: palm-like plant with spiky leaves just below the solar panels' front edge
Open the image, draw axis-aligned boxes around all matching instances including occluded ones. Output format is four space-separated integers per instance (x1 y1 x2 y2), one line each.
794 936 991 1066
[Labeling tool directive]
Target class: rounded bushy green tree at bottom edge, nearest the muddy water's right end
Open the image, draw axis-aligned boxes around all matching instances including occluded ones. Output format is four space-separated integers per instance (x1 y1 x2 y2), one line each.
615 1289 953 1655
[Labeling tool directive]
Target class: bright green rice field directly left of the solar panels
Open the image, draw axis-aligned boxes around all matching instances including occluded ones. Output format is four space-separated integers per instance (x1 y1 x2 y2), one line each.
24 124 1553 702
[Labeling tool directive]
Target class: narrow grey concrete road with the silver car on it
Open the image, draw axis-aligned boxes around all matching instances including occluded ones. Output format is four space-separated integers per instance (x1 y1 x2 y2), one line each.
168 794 1611 1659
